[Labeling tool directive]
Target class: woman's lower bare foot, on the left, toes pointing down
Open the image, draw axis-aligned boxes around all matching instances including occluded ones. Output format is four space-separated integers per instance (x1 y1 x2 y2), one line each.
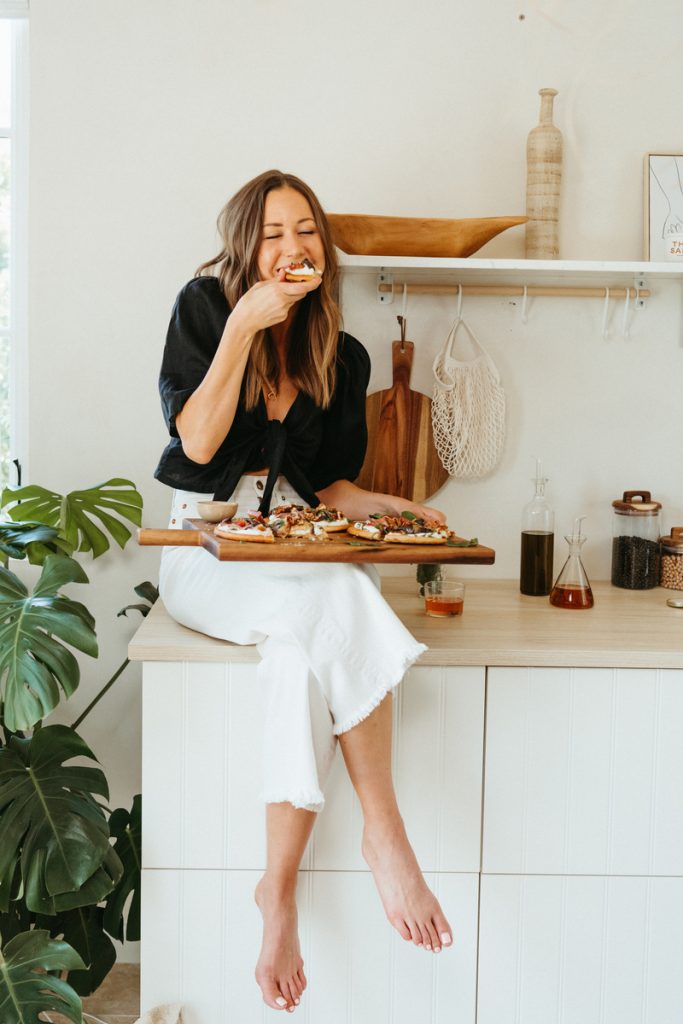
254 876 306 1013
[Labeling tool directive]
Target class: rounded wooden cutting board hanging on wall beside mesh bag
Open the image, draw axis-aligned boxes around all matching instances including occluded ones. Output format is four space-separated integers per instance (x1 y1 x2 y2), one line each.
355 341 449 504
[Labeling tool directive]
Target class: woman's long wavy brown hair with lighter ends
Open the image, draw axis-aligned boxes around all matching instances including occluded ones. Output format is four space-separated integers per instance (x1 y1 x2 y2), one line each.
195 170 341 410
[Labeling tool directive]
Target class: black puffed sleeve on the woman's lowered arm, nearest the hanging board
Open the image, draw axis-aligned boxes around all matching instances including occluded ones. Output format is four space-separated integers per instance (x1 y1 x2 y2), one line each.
310 334 370 490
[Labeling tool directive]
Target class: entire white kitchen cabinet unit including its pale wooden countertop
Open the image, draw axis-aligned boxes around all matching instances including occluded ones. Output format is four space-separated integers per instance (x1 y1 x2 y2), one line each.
134 580 683 1024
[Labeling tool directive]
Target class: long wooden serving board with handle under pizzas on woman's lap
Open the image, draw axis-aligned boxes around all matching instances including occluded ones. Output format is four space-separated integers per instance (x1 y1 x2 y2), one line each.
138 519 496 565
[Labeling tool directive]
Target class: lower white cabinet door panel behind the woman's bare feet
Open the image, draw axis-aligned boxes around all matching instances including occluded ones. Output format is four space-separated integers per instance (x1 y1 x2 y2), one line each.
140 869 478 1024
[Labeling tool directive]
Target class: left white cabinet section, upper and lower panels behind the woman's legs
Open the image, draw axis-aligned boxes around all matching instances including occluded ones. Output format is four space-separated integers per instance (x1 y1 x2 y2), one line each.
141 656 485 1024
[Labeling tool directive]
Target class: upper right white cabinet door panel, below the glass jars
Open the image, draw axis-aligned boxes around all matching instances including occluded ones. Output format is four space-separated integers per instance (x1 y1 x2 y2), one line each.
482 669 683 874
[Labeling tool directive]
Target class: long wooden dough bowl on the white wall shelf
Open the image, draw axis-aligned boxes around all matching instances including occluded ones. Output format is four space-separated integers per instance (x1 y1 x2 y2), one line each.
328 213 528 258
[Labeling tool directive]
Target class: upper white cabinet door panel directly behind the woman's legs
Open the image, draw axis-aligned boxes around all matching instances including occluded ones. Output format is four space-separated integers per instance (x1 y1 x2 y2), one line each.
142 663 484 871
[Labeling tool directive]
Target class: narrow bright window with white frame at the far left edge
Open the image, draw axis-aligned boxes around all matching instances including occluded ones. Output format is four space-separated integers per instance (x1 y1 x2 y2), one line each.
0 14 30 484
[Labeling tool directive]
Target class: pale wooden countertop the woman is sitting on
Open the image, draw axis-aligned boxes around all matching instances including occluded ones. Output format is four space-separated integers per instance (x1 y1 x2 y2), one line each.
128 577 683 669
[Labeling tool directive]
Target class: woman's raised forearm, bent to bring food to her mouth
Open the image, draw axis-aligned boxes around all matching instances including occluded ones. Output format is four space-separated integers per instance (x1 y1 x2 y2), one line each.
175 316 253 463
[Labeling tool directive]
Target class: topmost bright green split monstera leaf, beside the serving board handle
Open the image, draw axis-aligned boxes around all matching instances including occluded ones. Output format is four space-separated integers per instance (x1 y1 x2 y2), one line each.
0 477 142 558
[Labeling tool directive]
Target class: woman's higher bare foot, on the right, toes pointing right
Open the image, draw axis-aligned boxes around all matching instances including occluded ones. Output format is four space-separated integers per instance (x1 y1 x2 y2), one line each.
362 818 453 953
